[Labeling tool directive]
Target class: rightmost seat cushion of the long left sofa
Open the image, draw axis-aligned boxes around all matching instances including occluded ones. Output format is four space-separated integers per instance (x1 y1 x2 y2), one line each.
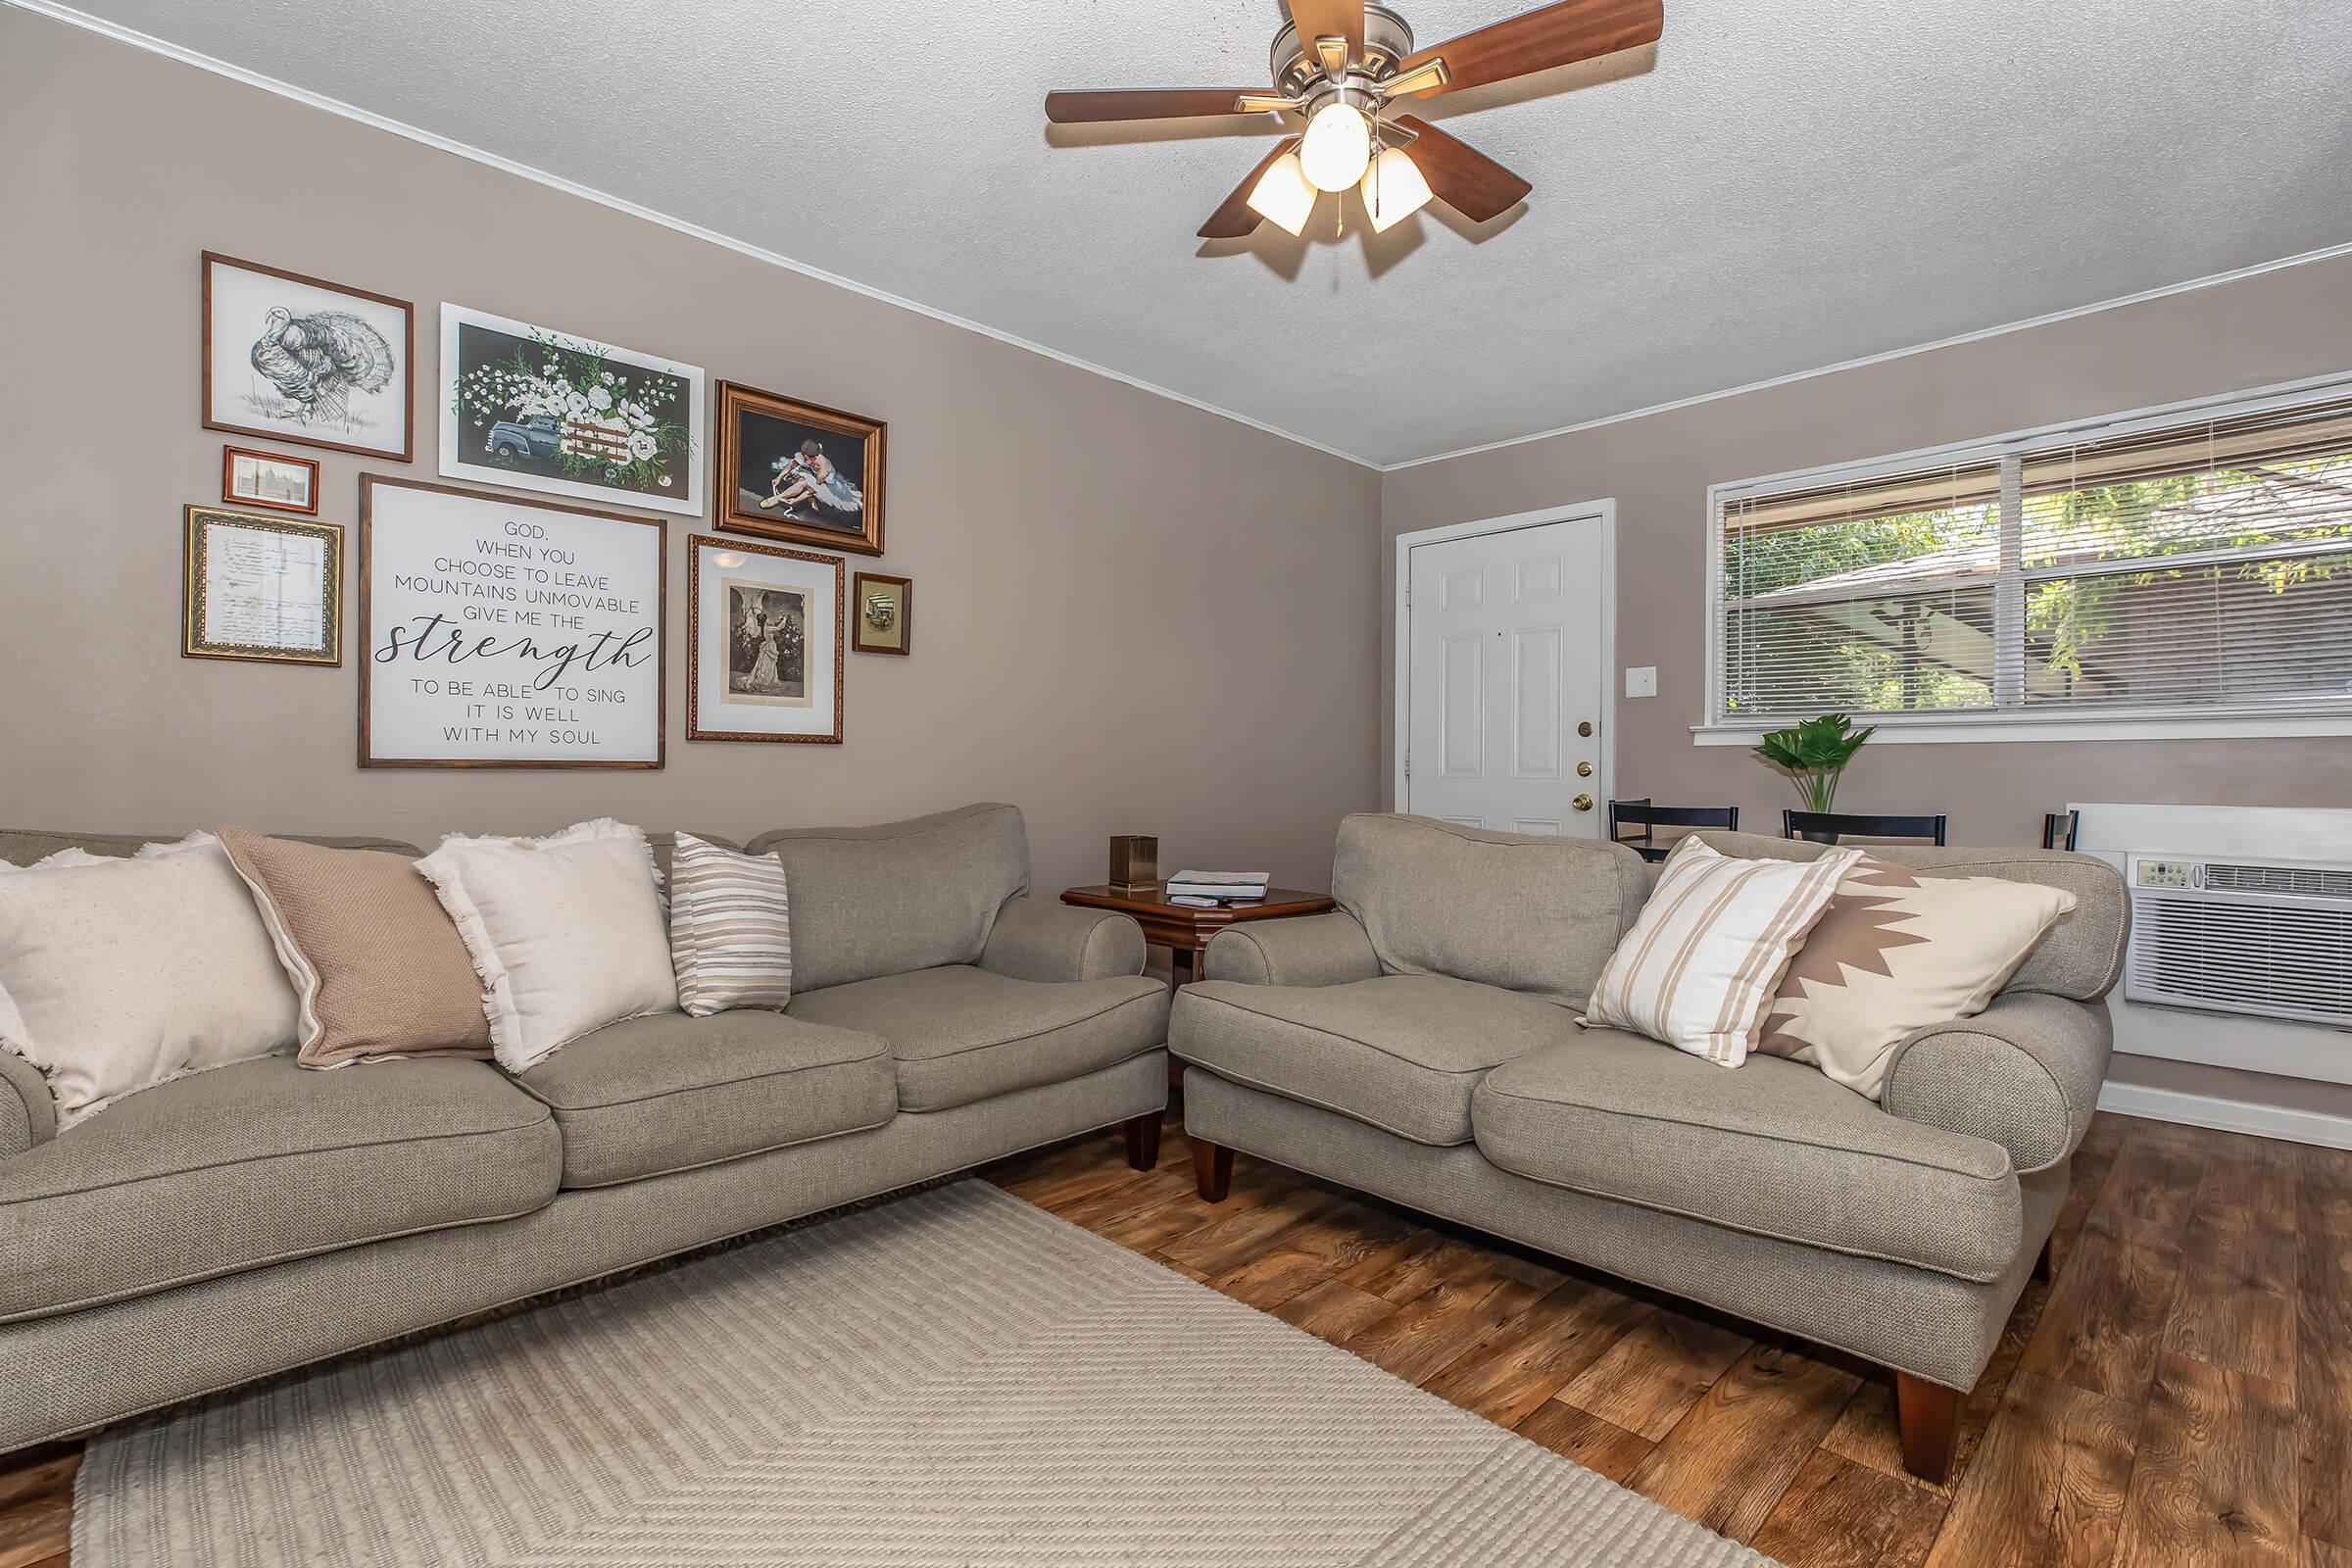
788 963 1169 1109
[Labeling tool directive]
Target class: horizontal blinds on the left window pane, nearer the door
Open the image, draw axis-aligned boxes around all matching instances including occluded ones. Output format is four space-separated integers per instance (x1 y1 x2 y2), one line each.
1719 459 2001 719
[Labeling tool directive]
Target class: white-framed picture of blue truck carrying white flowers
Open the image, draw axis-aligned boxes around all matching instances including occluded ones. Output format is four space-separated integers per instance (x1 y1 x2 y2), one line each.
440 303 704 517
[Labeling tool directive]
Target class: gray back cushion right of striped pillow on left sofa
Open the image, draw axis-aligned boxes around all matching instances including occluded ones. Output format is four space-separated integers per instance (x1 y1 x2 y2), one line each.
746 807 1028 992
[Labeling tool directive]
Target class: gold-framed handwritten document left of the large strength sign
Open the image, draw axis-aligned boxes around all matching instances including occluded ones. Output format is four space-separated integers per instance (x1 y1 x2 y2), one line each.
178 506 343 665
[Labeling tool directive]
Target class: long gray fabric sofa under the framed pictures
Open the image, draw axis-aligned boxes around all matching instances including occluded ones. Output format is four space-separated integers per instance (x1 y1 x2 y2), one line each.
0 807 1166 1450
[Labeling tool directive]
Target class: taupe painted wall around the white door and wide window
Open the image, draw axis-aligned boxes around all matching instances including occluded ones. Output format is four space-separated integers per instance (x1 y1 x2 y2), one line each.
1381 259 2352 844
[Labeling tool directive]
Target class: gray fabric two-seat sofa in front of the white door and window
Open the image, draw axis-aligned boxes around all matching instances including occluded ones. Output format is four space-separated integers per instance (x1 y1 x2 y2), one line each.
1169 815 2129 1479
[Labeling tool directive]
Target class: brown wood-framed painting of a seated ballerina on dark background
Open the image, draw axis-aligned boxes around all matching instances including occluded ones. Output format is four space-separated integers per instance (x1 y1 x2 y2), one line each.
715 381 887 555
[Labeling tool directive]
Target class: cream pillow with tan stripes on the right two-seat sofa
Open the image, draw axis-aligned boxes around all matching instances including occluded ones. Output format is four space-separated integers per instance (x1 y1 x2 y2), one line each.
1583 837 1863 1067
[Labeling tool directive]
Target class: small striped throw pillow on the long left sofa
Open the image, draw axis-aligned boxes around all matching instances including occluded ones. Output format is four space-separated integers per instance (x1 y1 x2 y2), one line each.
670 832 793 1018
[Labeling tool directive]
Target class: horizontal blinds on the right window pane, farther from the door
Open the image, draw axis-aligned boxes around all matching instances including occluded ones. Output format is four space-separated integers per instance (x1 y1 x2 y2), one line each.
2021 402 2352 710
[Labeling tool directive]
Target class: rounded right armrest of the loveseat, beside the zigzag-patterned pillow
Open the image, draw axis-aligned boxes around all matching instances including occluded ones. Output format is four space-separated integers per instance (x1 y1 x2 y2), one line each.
1880 992 2115 1175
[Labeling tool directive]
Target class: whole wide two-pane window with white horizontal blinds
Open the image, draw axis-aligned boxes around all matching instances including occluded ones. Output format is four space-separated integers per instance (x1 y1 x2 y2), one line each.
1710 388 2352 726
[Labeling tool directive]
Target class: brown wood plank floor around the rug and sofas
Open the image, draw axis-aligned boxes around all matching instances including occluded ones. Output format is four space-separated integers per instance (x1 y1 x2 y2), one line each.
0 1114 2352 1568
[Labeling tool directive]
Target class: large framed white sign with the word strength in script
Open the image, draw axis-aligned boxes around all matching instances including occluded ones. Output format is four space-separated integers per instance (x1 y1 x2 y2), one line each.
360 475 668 768
